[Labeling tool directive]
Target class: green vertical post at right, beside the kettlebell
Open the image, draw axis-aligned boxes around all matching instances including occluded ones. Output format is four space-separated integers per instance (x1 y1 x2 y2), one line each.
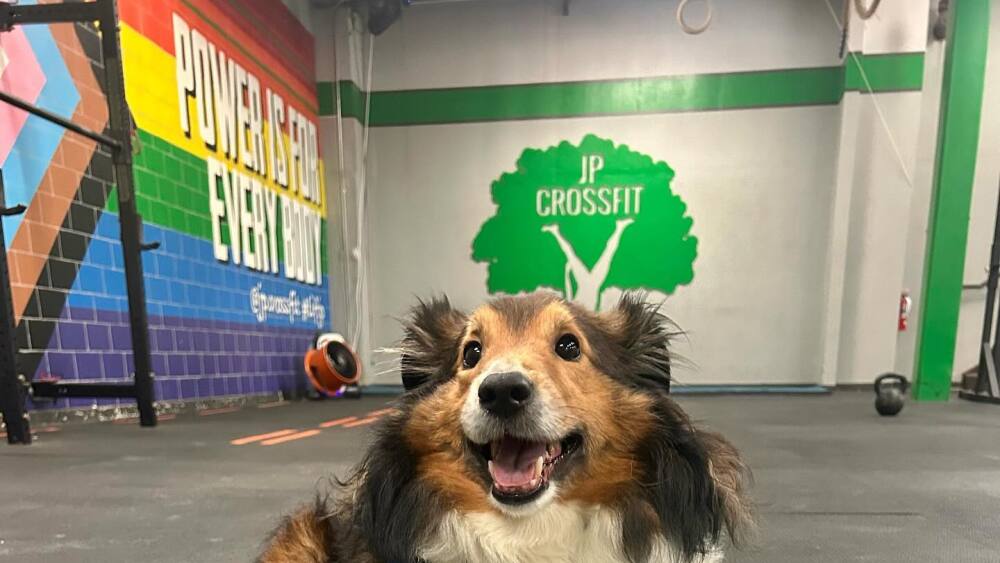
914 0 990 401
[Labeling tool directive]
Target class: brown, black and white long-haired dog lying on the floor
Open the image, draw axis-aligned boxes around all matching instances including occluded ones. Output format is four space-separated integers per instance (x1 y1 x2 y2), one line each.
259 293 754 563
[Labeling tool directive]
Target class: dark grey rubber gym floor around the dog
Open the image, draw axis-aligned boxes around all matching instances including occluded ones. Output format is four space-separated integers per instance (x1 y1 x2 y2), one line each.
0 392 1000 563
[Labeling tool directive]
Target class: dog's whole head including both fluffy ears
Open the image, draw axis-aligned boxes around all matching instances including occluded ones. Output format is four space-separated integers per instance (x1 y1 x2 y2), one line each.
404 293 670 516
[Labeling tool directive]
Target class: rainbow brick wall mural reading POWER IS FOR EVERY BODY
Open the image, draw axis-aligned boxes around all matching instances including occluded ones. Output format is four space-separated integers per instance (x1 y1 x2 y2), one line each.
0 0 330 408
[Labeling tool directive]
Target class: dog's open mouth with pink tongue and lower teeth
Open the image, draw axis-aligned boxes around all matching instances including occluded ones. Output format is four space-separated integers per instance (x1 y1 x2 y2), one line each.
479 433 583 504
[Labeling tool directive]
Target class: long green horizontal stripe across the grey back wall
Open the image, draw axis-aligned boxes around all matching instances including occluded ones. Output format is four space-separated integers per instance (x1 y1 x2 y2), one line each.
319 53 923 127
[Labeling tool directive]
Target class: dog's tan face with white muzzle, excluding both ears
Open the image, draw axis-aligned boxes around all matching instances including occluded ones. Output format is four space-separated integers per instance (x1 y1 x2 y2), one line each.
449 295 664 515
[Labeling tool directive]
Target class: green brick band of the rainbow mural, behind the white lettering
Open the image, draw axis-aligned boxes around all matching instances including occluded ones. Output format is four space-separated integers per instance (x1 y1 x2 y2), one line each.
107 130 328 274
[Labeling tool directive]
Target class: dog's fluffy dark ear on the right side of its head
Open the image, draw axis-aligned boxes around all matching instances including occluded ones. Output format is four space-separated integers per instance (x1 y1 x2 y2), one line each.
609 292 679 391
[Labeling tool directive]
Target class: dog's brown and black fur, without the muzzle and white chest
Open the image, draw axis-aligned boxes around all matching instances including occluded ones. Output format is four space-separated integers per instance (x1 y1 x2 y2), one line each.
260 293 753 563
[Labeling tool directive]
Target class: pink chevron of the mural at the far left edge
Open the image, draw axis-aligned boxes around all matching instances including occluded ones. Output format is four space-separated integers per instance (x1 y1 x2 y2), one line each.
0 27 45 164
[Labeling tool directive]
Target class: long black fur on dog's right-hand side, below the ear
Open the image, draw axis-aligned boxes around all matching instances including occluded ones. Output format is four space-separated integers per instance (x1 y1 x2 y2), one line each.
622 396 754 561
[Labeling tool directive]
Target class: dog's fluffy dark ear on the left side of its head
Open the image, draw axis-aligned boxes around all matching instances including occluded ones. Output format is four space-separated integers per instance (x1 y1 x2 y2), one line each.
400 296 467 391
